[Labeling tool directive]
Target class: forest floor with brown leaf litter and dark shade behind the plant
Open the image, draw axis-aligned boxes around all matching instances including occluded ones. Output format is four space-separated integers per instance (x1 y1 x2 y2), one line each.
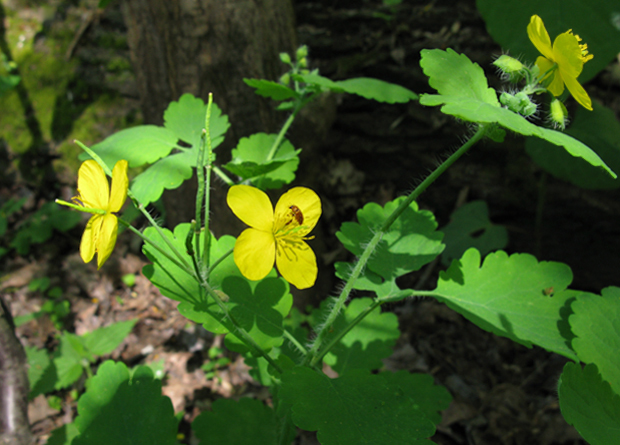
0 0 620 445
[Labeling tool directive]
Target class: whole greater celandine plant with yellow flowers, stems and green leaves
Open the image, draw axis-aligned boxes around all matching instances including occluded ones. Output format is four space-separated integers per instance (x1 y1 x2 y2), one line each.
52 15 620 445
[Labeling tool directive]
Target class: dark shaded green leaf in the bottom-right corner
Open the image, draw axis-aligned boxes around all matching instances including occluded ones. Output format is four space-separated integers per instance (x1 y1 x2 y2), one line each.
558 360 620 445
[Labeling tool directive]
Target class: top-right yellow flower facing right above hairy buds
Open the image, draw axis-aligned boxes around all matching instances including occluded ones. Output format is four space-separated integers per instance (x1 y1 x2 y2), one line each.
527 15 594 110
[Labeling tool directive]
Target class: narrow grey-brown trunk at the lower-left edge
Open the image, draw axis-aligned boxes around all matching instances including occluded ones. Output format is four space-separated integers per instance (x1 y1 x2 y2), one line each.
0 296 34 445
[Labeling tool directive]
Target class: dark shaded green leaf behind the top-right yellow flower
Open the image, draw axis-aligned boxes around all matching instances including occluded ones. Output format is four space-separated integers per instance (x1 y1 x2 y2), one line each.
476 0 620 82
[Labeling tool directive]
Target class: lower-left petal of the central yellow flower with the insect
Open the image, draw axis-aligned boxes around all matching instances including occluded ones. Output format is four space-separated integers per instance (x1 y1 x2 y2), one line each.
233 228 276 280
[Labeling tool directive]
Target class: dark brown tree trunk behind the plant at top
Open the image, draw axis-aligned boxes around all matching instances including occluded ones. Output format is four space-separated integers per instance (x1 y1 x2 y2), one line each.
123 0 296 230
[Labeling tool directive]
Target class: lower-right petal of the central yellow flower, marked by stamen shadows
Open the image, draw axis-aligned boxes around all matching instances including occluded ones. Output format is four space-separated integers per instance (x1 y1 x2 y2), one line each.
276 241 318 289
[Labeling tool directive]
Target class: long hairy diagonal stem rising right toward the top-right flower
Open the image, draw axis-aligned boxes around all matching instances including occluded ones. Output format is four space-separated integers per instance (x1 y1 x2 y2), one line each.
303 124 494 366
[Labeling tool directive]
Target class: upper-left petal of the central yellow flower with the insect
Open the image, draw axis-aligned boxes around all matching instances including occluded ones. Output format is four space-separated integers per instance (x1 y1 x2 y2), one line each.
226 185 273 231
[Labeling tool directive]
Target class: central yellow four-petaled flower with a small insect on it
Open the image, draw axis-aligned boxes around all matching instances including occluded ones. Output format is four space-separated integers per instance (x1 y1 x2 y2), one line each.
226 185 321 289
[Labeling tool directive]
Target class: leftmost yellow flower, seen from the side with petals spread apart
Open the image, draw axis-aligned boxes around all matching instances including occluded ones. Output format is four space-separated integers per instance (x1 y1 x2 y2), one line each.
72 159 129 269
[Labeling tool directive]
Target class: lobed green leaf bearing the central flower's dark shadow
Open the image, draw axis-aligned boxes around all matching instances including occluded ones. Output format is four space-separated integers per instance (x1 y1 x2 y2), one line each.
143 224 293 352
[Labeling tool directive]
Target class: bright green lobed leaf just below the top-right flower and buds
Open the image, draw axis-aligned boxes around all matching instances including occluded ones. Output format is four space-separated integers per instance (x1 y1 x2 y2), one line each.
420 49 616 178
